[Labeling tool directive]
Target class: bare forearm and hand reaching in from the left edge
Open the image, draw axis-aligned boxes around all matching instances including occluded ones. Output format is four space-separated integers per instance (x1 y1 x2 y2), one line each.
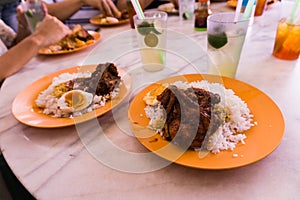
0 15 71 81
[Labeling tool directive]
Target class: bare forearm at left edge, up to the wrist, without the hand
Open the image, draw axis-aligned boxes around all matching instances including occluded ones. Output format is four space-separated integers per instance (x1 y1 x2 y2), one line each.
0 34 42 81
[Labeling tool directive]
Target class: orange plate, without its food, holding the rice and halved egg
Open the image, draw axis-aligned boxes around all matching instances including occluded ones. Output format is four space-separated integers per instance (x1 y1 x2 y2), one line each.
12 65 131 128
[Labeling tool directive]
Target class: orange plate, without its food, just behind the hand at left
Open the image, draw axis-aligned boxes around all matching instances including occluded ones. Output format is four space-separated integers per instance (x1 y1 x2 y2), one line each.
39 31 101 55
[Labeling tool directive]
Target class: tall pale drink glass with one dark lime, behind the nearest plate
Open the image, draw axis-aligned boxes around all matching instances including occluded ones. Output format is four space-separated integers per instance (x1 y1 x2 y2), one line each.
207 13 249 78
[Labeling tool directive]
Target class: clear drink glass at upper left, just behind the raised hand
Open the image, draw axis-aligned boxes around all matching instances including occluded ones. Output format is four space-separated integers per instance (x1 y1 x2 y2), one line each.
23 0 45 32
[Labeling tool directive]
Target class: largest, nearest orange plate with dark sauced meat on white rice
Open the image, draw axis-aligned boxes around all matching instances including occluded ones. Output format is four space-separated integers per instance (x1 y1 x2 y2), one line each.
128 74 285 170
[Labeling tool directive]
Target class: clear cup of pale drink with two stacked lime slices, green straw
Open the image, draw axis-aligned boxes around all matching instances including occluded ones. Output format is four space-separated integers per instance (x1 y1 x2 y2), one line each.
133 11 168 72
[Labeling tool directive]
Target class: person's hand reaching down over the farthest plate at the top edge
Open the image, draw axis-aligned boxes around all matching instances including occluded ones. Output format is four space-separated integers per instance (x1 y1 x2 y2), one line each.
82 0 122 18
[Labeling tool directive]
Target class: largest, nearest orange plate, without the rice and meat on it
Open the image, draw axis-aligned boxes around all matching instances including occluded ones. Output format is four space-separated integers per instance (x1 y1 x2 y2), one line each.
128 74 284 170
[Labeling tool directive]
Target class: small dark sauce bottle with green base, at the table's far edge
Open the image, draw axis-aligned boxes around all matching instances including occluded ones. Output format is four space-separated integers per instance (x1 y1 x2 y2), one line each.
195 0 211 31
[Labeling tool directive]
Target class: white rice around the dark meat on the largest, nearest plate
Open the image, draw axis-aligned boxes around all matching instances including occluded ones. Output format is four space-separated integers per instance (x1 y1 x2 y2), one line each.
145 80 254 153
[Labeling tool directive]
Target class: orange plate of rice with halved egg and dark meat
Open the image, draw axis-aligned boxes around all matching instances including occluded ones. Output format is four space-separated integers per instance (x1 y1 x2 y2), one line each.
12 63 131 128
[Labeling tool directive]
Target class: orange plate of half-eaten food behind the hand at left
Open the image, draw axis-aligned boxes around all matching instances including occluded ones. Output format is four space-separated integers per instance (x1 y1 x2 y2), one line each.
38 24 101 55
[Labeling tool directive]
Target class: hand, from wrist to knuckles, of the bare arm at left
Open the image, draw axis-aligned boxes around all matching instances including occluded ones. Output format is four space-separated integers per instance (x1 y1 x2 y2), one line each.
33 14 72 47
